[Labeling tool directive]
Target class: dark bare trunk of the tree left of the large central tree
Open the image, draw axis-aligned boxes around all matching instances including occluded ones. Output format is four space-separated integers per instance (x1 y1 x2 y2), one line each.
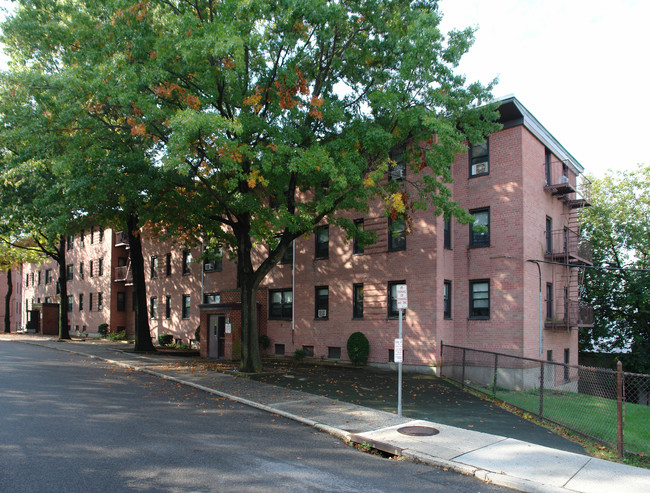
126 214 155 351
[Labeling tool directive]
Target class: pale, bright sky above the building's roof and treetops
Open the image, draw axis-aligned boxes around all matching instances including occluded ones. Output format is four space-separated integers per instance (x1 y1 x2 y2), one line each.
0 0 650 177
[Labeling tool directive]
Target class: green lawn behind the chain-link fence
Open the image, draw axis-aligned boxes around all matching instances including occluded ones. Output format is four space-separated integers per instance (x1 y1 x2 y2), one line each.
484 389 650 455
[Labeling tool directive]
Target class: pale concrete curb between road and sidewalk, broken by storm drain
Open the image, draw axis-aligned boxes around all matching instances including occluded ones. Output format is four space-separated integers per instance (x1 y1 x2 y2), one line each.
11 341 571 493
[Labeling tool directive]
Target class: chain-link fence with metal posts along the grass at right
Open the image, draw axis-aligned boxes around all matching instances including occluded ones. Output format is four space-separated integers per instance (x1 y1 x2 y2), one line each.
441 344 650 455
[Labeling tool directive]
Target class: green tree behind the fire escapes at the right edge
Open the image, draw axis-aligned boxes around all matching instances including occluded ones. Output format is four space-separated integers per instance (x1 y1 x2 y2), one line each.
580 165 650 372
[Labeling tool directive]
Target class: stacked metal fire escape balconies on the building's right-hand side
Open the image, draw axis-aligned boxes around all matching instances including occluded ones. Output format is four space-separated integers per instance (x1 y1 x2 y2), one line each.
544 160 593 330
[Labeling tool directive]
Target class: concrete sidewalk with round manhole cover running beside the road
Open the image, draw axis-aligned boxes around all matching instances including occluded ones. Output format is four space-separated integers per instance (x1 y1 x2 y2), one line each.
5 335 650 493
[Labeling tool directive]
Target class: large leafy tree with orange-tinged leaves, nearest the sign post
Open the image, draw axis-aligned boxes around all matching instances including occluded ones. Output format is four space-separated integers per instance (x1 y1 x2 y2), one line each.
5 0 496 371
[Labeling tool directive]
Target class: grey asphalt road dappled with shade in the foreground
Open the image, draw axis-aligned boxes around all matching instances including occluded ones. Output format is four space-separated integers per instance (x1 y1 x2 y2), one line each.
0 342 508 492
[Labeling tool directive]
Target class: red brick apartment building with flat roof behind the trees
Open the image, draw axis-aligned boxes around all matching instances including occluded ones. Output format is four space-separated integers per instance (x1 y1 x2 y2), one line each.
15 97 592 366
